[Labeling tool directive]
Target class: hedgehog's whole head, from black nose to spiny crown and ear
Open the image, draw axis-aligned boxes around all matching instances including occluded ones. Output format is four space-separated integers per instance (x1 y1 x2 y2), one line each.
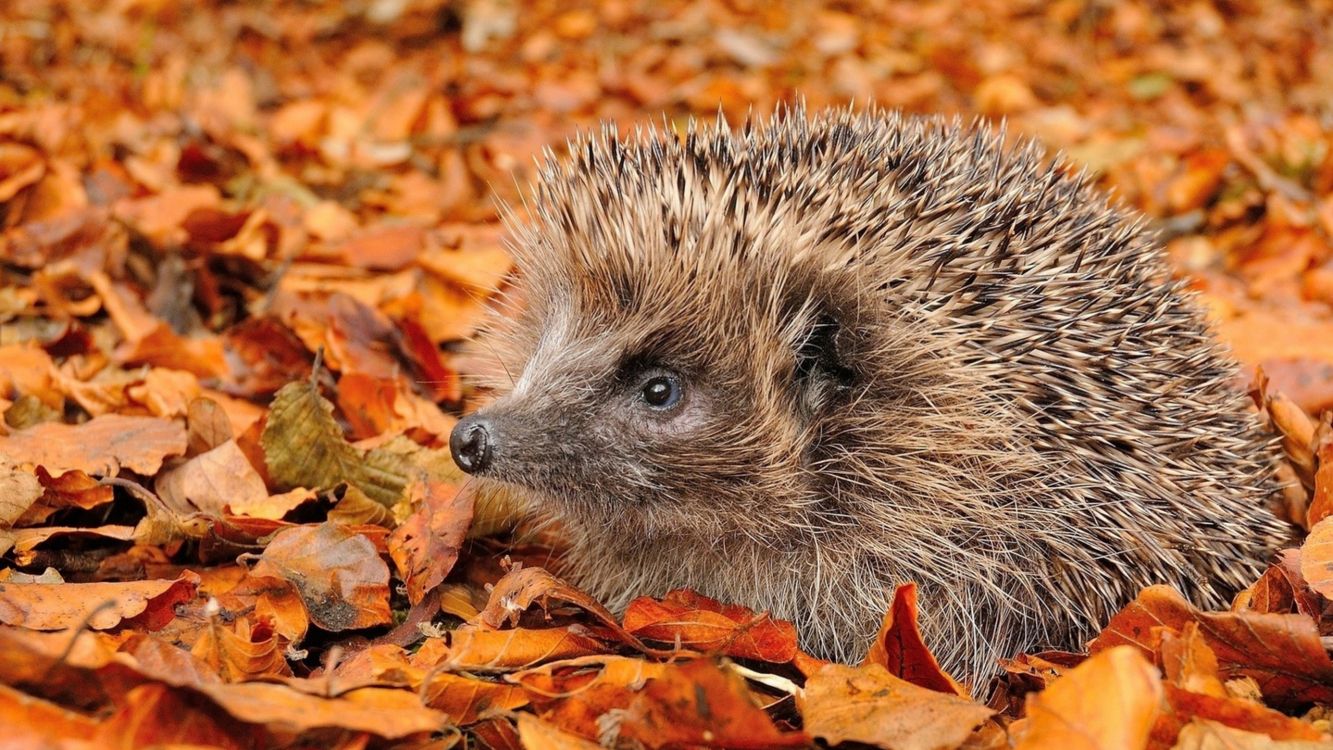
451 117 1013 546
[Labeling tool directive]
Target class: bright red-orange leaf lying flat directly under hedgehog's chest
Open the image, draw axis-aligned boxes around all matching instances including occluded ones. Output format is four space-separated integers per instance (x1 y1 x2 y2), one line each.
625 589 797 663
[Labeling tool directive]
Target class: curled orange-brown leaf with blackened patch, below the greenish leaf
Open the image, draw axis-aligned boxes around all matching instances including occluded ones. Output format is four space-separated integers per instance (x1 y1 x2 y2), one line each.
252 524 392 633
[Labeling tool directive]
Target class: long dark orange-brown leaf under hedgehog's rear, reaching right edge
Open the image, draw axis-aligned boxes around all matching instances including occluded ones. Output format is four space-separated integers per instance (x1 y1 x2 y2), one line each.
1089 586 1333 705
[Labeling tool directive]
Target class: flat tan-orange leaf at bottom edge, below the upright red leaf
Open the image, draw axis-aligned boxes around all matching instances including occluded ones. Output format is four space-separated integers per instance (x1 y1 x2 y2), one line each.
800 662 994 750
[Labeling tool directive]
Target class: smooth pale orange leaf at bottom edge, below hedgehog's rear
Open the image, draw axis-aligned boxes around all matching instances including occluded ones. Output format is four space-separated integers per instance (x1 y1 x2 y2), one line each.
1014 646 1162 750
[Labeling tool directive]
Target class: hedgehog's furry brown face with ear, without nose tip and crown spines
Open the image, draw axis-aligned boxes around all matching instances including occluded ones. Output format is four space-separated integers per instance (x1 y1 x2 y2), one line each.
463 226 890 546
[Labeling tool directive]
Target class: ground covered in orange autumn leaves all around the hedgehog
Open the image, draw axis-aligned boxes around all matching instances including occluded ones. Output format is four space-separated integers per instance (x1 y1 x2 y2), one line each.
0 0 1333 749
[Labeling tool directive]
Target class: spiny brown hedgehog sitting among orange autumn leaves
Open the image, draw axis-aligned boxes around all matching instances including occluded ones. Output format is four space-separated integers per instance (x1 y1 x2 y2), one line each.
451 104 1290 683
